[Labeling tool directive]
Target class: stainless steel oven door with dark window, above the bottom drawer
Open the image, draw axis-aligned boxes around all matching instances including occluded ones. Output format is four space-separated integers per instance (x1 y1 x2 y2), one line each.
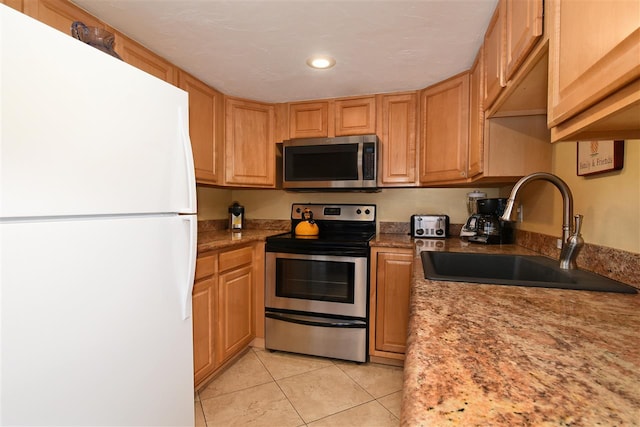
265 252 368 319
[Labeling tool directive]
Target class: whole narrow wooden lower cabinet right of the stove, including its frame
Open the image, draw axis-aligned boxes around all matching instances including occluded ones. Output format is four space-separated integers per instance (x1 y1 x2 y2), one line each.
369 248 413 360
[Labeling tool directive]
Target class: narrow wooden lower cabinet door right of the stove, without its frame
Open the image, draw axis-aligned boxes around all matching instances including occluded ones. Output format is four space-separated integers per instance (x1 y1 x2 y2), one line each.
375 250 413 354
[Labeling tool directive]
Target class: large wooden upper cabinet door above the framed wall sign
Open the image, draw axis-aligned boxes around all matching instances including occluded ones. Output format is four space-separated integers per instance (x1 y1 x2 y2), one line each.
548 0 640 125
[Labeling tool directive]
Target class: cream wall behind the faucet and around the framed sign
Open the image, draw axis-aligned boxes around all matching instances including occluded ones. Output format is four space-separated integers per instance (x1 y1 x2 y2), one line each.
501 140 640 253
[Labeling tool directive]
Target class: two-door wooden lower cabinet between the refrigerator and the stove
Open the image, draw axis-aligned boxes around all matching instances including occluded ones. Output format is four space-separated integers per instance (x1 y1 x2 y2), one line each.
192 245 256 388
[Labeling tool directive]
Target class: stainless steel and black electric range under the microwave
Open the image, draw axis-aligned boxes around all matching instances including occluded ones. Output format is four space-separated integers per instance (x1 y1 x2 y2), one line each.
265 204 376 362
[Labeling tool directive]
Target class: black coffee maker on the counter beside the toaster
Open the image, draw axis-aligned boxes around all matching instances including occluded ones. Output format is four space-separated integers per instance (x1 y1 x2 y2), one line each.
465 198 514 244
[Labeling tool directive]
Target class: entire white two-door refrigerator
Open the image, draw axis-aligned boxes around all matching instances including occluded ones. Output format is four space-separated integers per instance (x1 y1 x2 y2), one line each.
0 4 197 426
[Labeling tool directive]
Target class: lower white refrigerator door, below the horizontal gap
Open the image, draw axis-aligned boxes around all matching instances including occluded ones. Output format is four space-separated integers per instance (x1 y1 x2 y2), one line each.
0 215 195 426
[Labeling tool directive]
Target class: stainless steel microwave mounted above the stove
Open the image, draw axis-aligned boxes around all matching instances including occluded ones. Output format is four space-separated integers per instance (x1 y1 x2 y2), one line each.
282 135 378 191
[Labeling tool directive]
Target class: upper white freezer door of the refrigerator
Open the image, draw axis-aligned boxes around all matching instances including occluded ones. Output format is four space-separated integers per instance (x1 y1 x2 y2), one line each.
0 5 196 218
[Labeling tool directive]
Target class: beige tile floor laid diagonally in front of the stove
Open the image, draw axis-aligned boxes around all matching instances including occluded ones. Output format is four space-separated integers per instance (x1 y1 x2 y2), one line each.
195 348 402 427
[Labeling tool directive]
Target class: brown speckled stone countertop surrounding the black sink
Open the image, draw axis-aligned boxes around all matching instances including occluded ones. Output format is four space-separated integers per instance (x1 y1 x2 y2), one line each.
400 236 640 426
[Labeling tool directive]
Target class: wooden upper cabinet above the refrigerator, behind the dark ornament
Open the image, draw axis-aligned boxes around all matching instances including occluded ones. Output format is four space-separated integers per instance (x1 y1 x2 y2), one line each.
23 0 105 36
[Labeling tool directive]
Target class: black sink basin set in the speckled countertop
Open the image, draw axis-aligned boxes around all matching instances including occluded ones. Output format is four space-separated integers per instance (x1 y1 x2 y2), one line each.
421 251 637 294
